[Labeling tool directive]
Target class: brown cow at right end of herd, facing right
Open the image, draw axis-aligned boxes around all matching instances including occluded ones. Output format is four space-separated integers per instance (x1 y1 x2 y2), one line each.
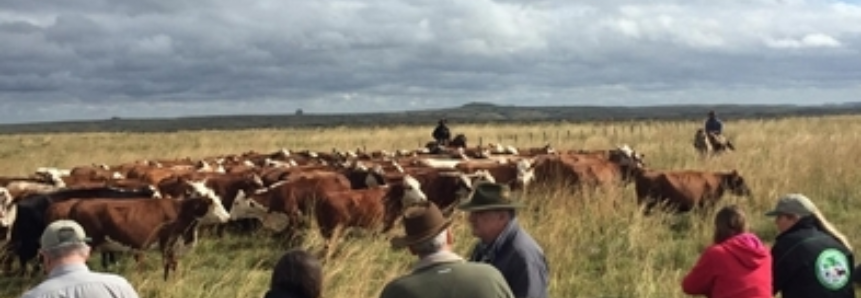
634 170 751 214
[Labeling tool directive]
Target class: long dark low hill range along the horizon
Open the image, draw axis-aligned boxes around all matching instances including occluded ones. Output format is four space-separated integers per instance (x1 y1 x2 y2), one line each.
0 102 861 134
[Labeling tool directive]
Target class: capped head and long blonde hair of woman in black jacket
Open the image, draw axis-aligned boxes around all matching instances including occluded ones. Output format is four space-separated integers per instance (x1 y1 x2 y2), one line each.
765 193 852 250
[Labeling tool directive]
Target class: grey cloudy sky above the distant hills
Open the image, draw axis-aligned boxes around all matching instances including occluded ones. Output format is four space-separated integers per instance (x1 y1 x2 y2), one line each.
0 0 861 123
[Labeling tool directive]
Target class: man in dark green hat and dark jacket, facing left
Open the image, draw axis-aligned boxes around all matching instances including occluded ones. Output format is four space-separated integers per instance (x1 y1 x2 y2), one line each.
458 182 549 298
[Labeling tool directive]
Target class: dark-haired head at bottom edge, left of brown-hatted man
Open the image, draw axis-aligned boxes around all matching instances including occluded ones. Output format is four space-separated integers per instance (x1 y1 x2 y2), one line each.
269 249 323 298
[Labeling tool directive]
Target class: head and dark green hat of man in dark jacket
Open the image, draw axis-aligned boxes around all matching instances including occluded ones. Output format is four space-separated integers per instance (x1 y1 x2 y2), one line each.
458 182 522 243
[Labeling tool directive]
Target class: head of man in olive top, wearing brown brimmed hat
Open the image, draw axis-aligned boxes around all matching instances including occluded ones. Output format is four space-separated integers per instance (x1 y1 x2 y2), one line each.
391 202 454 258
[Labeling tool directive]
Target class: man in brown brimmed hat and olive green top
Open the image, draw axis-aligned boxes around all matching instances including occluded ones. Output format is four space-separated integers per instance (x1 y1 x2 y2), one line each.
380 202 514 298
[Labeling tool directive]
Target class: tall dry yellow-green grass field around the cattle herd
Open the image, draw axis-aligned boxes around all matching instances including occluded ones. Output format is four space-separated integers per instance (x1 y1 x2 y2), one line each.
0 116 861 298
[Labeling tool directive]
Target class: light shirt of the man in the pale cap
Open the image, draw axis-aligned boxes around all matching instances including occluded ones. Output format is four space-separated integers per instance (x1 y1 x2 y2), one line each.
21 264 138 298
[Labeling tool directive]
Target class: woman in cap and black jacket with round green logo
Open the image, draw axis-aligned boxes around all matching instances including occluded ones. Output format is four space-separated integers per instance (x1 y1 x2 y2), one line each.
765 193 855 298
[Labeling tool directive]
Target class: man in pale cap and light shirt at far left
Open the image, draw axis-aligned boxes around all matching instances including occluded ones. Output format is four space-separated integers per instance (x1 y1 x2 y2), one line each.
21 220 138 298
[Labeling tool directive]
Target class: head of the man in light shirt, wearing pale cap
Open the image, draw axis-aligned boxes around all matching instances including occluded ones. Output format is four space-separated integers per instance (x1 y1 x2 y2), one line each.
39 219 90 272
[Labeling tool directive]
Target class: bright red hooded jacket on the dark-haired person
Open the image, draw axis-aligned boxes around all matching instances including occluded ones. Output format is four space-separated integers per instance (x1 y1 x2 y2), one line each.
682 233 772 298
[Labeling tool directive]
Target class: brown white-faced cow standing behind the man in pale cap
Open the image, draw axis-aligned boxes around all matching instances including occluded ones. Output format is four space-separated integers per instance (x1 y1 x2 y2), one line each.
69 197 230 280
